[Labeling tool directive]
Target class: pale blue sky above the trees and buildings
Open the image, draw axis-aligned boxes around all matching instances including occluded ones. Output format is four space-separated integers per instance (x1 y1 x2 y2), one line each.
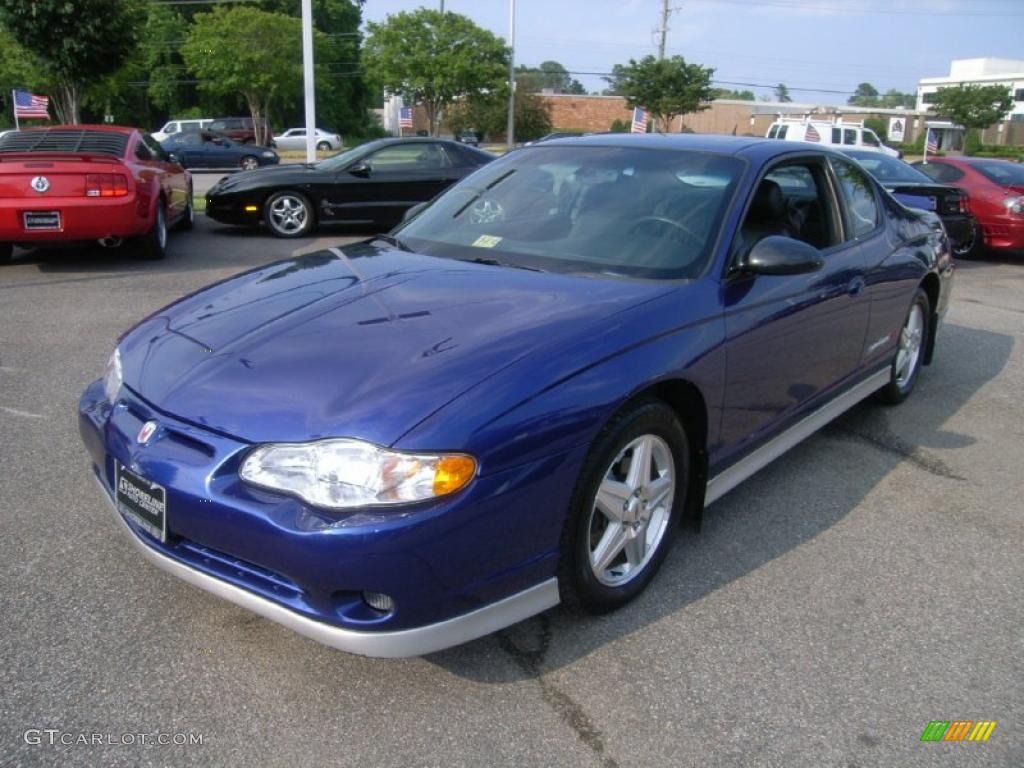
362 0 1024 104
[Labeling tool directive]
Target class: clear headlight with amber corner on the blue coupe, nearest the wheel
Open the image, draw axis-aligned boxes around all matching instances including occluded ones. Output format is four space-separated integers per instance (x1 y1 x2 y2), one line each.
239 438 476 509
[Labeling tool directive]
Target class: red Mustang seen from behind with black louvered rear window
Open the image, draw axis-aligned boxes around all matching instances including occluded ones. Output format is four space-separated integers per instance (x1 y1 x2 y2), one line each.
0 125 194 262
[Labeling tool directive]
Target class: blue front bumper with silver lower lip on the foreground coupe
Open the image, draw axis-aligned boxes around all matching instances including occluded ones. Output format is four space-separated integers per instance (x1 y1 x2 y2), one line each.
79 382 582 656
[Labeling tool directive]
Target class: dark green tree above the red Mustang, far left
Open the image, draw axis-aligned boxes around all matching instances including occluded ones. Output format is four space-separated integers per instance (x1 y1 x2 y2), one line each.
0 0 141 123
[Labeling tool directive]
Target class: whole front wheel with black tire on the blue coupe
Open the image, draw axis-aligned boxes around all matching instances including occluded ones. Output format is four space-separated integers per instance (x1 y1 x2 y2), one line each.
558 400 689 613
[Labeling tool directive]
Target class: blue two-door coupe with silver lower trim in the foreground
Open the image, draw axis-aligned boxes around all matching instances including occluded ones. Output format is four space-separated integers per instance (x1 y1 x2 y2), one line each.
79 135 953 656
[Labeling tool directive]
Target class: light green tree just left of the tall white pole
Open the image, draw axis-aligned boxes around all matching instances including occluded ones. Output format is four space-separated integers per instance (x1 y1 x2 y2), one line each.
181 6 313 143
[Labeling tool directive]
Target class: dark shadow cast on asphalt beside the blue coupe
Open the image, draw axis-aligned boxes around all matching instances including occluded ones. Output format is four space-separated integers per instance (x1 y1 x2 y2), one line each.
426 324 1014 683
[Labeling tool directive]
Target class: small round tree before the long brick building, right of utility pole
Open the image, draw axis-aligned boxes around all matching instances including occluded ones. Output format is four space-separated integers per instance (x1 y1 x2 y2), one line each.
612 56 715 131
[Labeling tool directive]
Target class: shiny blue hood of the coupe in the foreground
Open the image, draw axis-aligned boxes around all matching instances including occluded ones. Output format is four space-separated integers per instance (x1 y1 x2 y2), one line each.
120 244 671 445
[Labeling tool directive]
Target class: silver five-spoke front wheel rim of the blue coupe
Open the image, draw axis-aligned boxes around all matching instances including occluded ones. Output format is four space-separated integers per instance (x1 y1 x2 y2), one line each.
588 434 676 587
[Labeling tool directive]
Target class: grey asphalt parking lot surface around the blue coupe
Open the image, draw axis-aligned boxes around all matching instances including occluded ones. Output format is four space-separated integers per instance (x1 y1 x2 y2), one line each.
0 219 1024 768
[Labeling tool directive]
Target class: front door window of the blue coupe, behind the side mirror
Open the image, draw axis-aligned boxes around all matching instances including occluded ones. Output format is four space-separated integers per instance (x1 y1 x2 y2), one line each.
739 160 839 252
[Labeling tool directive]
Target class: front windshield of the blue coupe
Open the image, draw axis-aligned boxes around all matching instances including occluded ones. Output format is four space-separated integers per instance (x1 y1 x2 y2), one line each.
398 144 743 280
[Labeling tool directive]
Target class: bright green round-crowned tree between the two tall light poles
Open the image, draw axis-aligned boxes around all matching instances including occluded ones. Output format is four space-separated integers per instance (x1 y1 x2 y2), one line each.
364 8 509 135
